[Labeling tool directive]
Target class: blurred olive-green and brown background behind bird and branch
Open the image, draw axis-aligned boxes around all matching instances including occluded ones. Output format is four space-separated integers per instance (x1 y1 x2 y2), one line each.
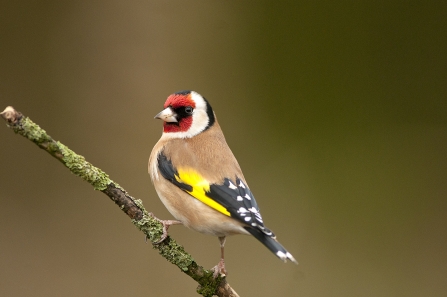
0 0 447 297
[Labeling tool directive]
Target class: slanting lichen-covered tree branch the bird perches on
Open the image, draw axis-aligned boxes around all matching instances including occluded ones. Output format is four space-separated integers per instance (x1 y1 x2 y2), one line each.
0 106 239 297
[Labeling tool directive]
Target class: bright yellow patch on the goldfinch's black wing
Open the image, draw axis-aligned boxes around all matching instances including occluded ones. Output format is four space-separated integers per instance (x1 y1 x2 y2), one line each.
175 168 230 216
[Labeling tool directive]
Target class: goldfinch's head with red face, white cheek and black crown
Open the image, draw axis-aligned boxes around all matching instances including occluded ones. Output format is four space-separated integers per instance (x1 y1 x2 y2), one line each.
155 91 215 138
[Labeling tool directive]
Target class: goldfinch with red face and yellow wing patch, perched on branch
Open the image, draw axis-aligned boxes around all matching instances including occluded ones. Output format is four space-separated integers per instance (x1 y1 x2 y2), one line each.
148 90 298 278
